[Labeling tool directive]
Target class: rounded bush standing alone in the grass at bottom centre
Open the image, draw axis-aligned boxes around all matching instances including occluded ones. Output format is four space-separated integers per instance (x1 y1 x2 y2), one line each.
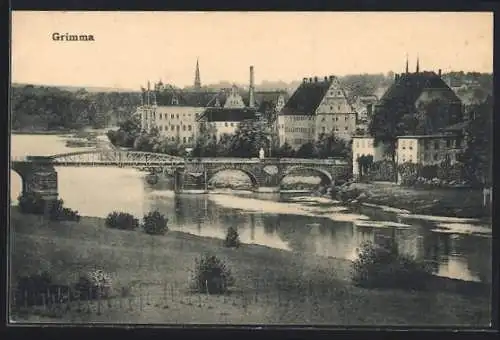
193 255 234 294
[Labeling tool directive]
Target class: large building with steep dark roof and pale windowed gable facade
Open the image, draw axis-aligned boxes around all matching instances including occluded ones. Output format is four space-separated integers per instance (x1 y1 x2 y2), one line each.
277 76 356 149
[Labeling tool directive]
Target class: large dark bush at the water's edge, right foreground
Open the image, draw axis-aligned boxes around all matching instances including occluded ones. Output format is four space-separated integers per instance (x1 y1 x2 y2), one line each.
351 242 430 289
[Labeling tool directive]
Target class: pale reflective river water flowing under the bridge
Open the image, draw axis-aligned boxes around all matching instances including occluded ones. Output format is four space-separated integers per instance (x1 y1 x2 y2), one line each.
10 135 491 283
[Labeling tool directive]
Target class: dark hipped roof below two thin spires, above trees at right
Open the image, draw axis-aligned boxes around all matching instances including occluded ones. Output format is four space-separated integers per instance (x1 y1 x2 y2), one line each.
379 72 460 106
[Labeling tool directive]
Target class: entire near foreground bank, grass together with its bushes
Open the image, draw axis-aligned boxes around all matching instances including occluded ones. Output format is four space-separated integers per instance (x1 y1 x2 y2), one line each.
11 201 490 325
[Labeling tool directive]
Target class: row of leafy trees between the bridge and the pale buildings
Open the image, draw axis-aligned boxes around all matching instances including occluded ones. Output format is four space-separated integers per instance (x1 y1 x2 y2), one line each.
108 117 351 158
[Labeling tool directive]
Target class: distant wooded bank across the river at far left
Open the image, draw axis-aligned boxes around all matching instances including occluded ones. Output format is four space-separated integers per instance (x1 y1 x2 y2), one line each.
11 85 140 131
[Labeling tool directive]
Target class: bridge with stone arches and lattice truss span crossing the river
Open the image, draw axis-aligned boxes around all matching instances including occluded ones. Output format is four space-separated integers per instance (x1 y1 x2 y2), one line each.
11 150 350 200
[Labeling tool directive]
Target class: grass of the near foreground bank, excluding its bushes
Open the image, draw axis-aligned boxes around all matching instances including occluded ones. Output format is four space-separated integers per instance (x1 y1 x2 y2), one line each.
11 208 490 326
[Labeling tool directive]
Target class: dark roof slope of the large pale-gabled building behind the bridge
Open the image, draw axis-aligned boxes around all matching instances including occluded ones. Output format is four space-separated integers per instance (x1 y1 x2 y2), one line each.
280 78 332 115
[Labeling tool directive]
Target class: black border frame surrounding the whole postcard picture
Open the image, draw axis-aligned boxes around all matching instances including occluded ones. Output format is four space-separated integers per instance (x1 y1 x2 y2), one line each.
0 0 500 338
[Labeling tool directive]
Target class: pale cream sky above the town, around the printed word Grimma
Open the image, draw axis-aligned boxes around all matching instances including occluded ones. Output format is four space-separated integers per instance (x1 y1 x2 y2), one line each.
11 11 493 89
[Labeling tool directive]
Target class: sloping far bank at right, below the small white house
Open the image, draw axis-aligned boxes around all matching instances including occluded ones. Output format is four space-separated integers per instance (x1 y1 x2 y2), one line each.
350 183 491 218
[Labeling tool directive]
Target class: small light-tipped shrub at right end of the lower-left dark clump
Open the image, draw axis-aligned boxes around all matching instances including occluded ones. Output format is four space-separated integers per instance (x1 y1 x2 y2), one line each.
75 269 113 300
